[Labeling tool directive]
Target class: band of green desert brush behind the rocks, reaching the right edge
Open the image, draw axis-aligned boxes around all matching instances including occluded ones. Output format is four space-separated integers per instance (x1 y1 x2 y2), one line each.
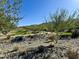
14 9 79 35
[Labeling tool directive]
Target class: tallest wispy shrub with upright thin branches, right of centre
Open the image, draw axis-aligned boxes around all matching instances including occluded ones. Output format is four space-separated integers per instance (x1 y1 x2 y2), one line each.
50 9 67 31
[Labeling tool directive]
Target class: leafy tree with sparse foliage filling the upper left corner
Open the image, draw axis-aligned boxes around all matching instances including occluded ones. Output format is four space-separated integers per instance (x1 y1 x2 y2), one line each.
0 0 22 34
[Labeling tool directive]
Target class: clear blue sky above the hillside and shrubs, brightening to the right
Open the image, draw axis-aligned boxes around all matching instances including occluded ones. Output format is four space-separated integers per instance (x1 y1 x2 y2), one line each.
19 0 79 26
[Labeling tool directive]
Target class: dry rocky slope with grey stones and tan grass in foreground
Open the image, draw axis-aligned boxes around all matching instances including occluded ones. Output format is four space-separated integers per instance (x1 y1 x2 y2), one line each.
0 35 79 59
